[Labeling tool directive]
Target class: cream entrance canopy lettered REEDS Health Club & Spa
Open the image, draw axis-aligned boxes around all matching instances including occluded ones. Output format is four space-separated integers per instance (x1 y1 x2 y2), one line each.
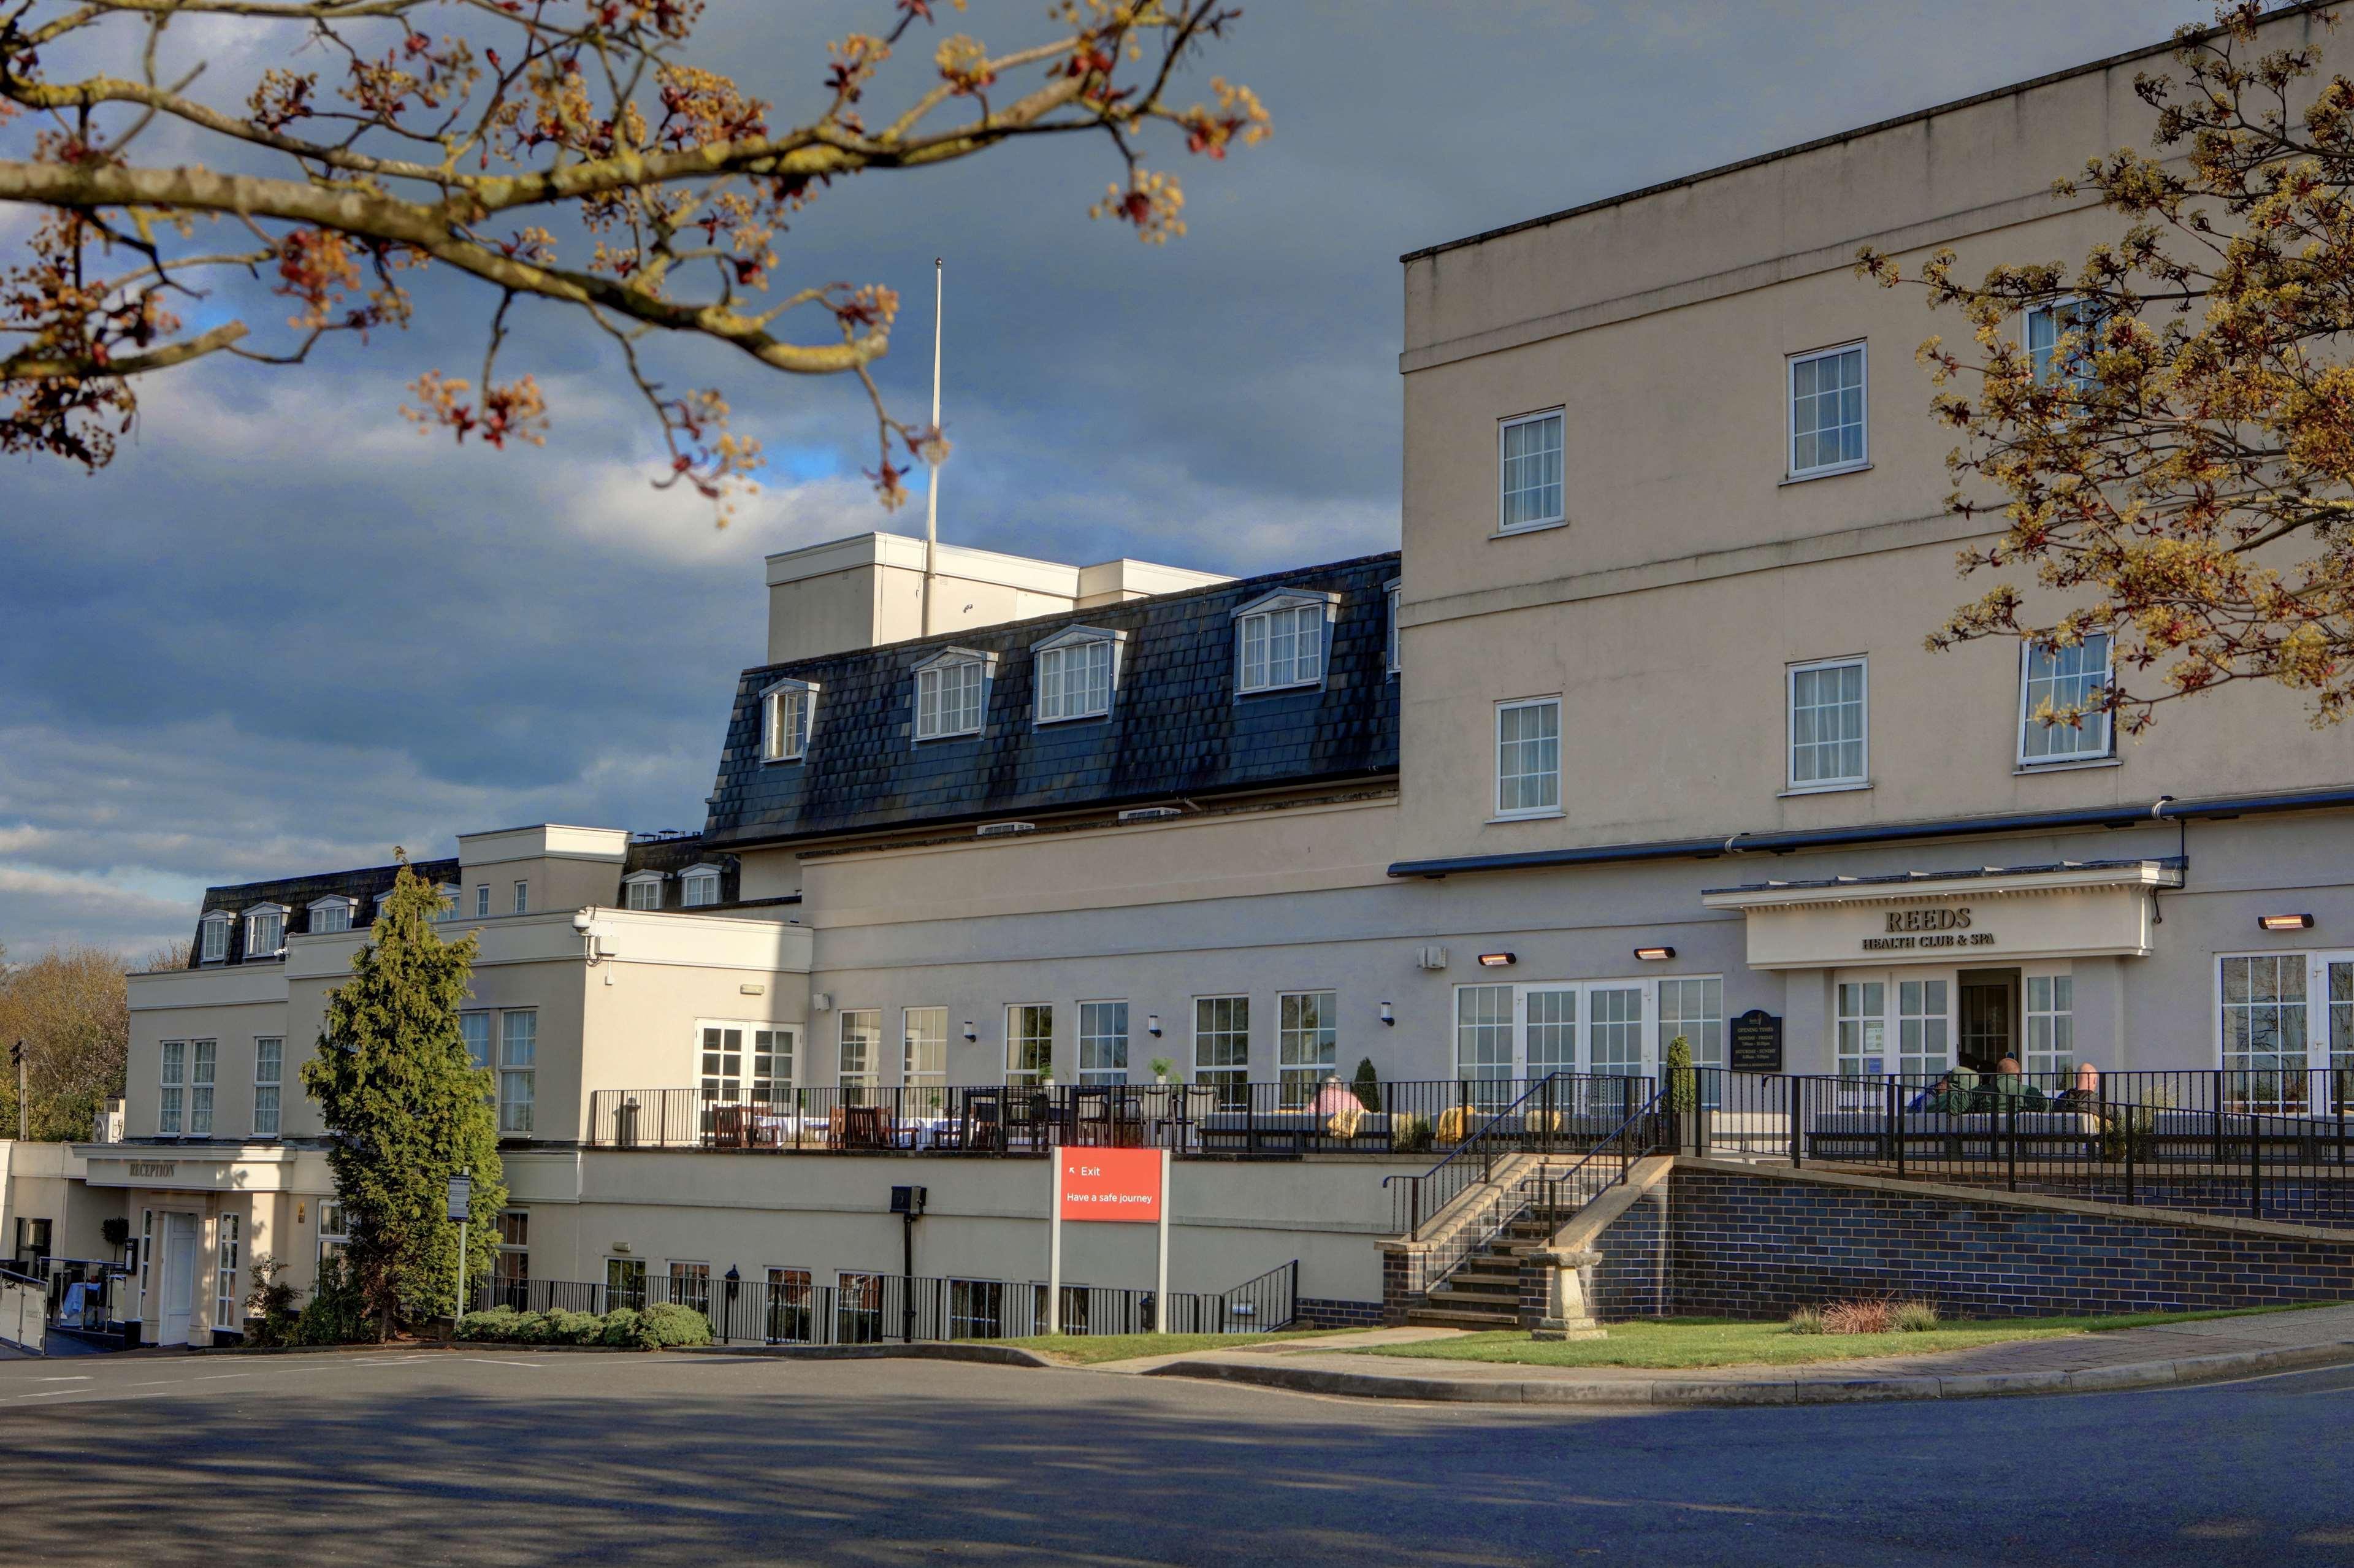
1702 859 2182 970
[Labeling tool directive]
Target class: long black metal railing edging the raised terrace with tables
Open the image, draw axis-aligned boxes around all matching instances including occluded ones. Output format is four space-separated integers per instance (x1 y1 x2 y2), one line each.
589 1074 1650 1156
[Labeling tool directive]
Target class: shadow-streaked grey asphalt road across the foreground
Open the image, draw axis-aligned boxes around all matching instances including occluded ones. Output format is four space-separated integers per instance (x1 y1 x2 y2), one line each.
0 1352 2354 1568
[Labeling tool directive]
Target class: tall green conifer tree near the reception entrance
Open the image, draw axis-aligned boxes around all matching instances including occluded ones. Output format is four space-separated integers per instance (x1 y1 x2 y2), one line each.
301 855 506 1333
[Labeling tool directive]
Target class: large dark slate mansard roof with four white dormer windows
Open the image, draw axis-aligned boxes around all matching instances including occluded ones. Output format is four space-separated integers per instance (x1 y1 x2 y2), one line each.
704 551 1398 845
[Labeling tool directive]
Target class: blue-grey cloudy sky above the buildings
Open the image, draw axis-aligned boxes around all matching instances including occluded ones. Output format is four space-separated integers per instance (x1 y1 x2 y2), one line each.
0 0 2211 958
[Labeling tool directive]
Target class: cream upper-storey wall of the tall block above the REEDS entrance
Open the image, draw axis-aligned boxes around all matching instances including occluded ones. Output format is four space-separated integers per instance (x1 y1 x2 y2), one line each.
1398 2 2354 859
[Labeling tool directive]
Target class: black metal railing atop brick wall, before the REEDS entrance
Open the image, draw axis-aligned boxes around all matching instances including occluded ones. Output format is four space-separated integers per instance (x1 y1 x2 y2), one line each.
1692 1069 2354 1226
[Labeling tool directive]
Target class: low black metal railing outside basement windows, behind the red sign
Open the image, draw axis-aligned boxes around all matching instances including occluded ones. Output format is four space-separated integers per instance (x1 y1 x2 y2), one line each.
471 1262 1299 1344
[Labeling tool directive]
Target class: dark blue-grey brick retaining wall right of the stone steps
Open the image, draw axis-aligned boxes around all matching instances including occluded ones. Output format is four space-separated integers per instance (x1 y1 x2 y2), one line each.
1667 1165 2354 1318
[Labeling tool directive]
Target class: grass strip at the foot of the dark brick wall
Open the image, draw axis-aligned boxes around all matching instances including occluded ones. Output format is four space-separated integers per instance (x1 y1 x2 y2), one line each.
1349 1302 2323 1368
